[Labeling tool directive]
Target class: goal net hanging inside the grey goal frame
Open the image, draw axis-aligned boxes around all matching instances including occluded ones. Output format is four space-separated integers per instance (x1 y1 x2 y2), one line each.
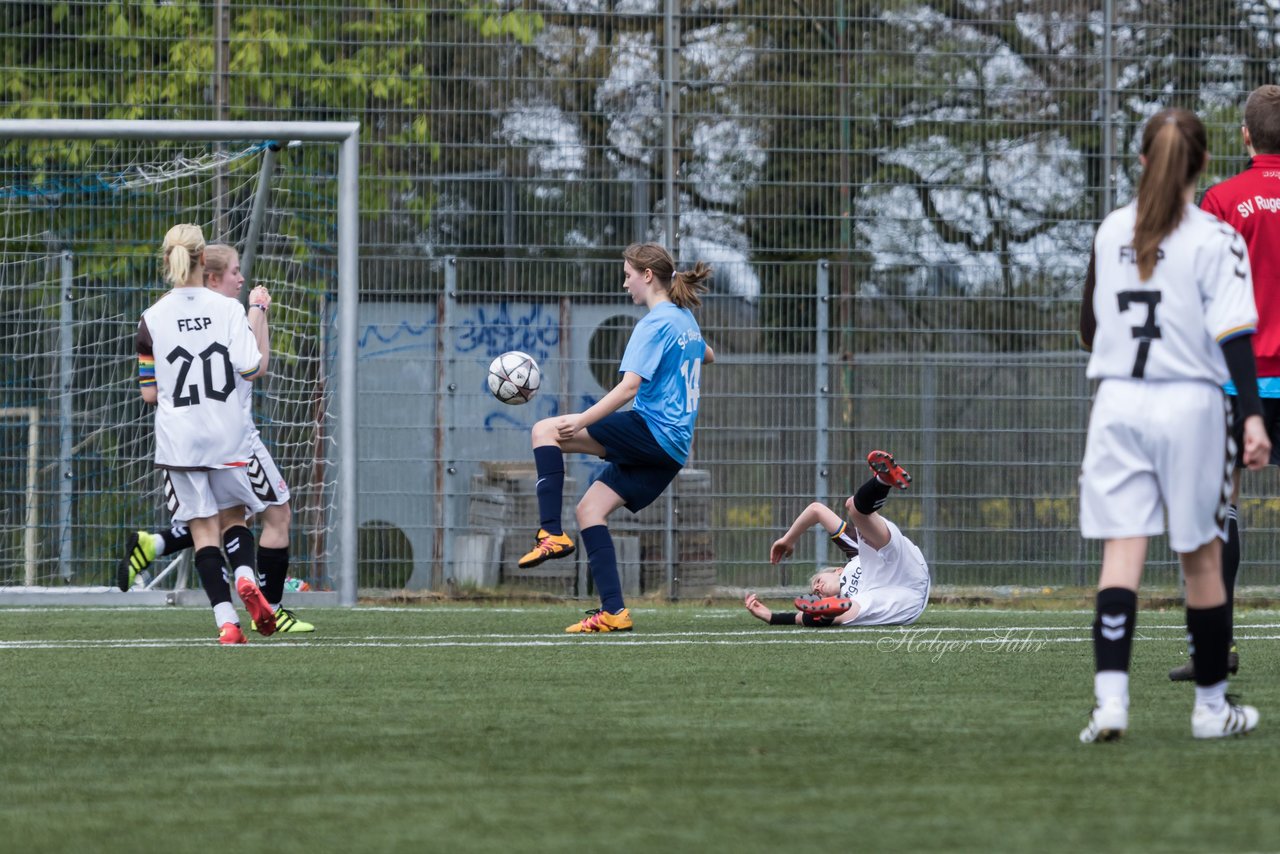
0 123 355 599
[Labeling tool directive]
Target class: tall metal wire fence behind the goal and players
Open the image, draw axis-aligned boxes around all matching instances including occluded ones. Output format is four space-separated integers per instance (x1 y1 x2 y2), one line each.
0 0 1280 593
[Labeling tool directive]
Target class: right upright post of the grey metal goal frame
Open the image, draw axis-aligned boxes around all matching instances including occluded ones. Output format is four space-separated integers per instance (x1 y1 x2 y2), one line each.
338 125 360 607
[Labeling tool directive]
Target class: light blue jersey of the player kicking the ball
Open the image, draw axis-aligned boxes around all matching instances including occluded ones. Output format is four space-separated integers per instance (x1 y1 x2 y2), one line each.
618 302 707 465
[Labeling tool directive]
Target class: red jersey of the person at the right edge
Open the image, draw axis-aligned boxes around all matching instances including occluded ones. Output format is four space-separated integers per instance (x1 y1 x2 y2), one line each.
1201 154 1280 376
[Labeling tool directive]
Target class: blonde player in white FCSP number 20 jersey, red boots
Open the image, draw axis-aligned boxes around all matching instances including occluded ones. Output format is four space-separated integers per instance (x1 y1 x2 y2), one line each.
137 224 275 644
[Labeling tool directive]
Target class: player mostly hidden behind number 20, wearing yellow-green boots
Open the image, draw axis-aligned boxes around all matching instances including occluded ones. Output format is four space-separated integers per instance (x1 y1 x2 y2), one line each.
116 243 315 632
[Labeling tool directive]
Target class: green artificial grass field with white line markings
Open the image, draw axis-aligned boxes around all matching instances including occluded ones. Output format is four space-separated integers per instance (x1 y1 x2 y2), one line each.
0 604 1280 854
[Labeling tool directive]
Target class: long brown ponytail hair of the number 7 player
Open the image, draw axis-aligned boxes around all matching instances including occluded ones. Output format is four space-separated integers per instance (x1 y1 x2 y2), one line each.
1133 108 1208 282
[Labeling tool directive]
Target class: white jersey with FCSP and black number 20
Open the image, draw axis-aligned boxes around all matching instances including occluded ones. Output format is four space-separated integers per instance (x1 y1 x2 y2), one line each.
137 287 261 470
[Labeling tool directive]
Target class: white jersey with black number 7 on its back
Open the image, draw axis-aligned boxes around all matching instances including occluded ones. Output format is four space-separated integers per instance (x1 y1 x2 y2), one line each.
1087 202 1258 385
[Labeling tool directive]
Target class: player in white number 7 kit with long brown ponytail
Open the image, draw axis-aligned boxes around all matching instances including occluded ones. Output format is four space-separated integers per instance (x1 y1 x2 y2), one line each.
1080 109 1271 743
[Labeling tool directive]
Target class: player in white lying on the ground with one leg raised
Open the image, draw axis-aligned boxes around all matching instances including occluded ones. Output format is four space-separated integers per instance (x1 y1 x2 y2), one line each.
744 451 929 626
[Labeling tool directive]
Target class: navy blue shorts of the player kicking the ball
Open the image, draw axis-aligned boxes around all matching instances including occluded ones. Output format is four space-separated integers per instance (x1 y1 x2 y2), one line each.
586 410 682 513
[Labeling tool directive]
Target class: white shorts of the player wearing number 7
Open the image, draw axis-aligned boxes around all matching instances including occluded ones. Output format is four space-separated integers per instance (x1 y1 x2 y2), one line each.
1080 379 1235 553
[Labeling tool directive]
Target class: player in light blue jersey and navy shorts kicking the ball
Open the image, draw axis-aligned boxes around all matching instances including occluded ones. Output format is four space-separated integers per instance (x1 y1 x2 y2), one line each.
520 243 716 634
